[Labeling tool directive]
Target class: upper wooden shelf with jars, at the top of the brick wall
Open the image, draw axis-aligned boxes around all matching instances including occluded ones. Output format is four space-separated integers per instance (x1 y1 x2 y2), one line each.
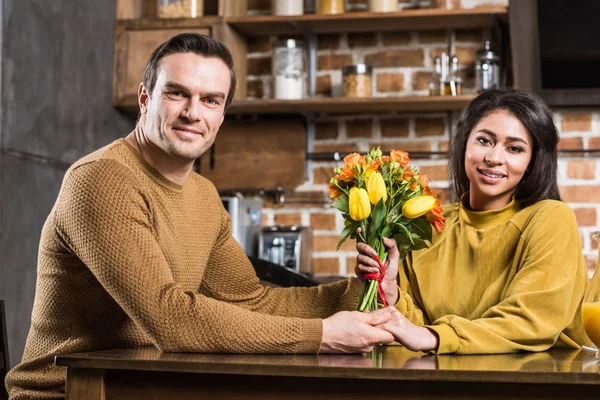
225 6 508 36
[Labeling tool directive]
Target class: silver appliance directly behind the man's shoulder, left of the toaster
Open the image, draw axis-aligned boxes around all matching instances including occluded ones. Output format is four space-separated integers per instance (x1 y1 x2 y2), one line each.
221 194 262 255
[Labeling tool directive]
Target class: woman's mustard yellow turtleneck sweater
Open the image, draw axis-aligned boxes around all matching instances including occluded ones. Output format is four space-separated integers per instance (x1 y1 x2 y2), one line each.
396 200 589 354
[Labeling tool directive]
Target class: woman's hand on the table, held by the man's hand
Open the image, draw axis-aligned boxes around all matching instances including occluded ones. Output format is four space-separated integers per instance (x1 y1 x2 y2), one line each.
377 307 439 351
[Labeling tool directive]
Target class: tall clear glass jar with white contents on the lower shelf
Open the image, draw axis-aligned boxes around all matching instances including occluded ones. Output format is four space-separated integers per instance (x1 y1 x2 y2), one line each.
273 39 304 100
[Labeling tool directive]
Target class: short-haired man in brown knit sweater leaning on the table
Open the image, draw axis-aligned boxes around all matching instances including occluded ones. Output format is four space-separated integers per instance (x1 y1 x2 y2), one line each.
6 34 393 399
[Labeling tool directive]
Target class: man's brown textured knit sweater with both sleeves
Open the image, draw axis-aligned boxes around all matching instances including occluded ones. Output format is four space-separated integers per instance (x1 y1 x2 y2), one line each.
6 139 360 399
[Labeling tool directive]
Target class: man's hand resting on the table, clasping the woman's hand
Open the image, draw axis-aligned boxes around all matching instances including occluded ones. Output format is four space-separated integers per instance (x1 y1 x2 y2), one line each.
319 307 397 353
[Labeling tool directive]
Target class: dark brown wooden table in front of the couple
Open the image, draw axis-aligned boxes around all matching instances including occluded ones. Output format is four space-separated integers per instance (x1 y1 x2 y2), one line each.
56 346 600 400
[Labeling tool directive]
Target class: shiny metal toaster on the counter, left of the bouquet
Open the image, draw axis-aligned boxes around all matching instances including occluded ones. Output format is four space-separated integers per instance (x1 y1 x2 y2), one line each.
258 225 312 274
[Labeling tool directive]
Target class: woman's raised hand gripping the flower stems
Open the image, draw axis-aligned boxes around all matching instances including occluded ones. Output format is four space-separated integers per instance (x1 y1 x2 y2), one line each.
354 228 400 305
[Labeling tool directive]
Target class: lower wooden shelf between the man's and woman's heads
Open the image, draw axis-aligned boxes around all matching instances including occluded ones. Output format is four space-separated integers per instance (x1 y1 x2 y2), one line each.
227 95 475 115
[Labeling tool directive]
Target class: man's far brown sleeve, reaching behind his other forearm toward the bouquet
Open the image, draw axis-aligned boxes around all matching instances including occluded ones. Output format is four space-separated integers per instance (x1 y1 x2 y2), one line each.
200 203 361 318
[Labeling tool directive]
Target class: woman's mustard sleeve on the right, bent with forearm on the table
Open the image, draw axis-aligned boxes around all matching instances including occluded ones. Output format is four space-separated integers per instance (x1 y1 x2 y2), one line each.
429 202 586 354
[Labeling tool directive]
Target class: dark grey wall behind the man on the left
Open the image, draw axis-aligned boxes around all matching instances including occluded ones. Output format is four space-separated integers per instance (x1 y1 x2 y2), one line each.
0 0 135 365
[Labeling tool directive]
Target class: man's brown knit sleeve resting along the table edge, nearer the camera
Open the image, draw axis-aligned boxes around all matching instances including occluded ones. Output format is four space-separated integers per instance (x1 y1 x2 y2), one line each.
54 160 322 353
